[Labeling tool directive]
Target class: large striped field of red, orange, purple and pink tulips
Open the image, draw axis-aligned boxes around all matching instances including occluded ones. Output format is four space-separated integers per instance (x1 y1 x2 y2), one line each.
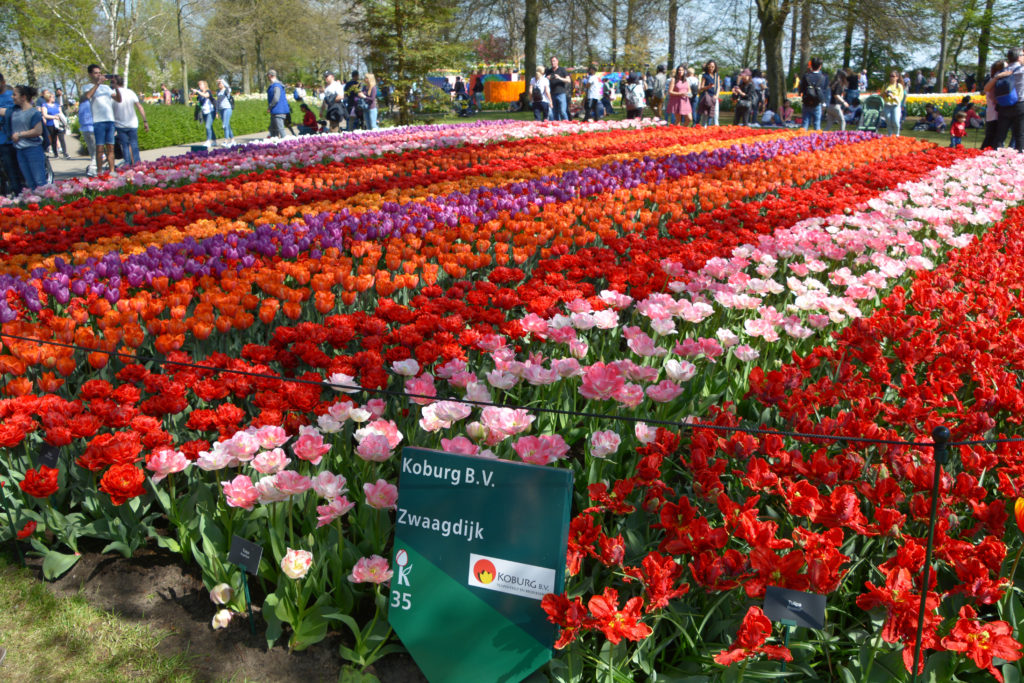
0 121 1024 682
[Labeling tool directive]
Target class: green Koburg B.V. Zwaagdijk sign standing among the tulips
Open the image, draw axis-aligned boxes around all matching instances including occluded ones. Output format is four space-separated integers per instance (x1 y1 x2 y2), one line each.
388 447 572 683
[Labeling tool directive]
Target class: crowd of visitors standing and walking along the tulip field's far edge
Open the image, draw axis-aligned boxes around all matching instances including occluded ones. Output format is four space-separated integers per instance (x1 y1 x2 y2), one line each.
0 48 1024 194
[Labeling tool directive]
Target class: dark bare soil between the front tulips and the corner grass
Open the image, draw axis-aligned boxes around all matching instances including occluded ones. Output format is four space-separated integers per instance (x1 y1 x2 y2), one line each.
28 549 427 683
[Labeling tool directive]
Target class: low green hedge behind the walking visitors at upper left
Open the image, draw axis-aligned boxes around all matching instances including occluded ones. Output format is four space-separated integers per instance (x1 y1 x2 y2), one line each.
138 99 299 150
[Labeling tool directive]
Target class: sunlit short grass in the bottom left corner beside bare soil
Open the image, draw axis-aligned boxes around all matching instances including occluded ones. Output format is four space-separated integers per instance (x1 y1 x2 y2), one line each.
0 555 195 683
